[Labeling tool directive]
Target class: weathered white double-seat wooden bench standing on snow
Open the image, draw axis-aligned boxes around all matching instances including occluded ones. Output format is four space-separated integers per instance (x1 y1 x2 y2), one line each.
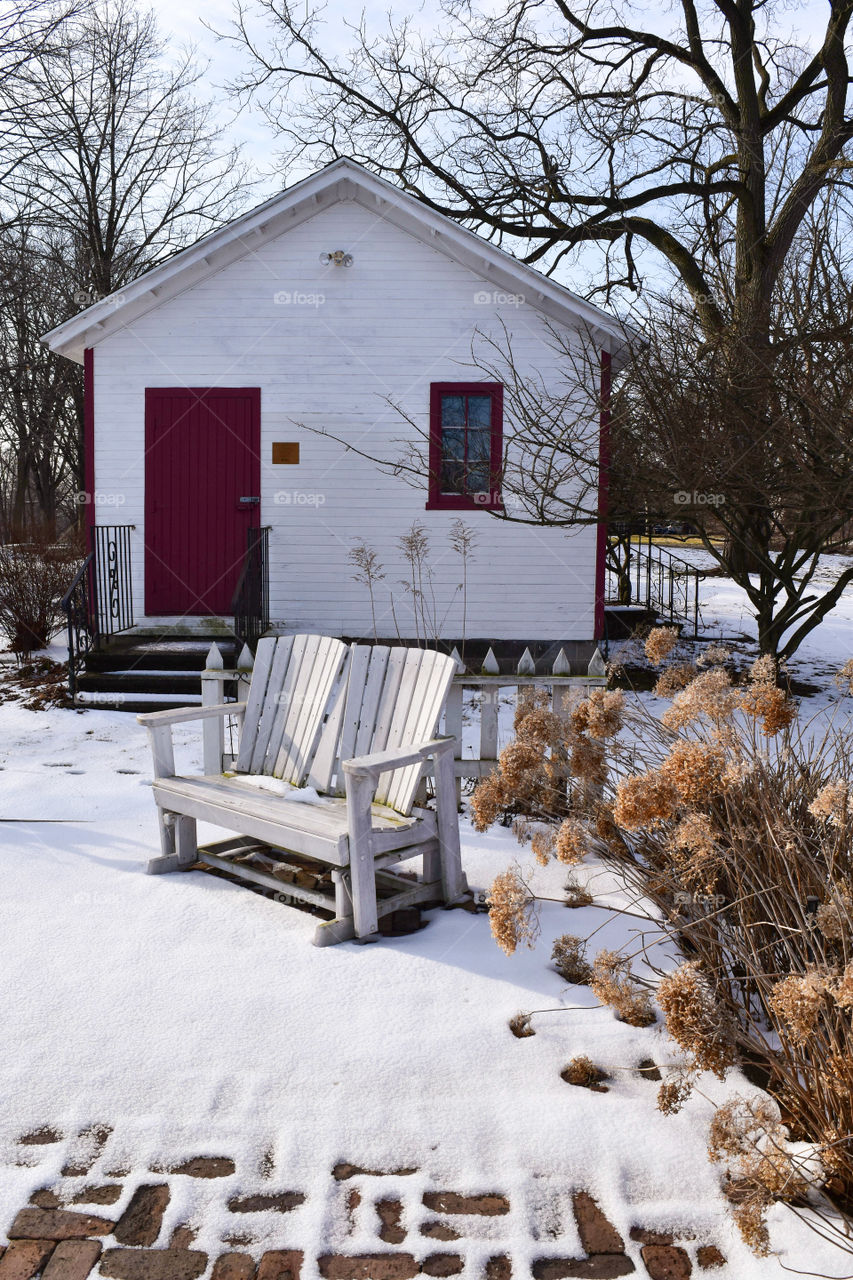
137 635 467 946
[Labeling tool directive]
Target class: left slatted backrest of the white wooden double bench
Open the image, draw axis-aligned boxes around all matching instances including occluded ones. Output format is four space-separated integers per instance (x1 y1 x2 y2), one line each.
234 635 348 787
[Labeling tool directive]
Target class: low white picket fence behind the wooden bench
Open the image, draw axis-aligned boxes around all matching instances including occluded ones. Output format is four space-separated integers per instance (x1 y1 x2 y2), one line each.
201 644 607 786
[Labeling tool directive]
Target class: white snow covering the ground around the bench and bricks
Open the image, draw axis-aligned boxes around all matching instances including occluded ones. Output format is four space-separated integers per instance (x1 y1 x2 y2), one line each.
0 579 853 1280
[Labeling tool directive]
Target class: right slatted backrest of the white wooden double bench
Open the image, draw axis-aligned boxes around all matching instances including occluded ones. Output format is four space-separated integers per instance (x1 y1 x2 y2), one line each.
309 644 456 814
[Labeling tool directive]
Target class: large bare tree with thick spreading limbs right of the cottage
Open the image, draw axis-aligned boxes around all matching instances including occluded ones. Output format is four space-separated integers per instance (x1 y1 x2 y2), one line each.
220 0 853 650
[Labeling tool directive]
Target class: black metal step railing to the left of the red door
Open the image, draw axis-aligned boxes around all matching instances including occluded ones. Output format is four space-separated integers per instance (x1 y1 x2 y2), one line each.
61 525 136 698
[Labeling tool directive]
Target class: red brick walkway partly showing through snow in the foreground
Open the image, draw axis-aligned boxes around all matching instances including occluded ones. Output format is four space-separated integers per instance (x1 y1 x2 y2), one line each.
0 1125 725 1280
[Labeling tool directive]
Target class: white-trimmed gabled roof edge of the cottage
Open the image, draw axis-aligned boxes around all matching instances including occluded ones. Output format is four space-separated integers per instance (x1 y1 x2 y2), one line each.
42 159 626 365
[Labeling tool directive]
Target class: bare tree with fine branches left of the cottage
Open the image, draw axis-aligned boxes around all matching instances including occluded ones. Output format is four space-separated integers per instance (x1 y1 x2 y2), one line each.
0 0 252 527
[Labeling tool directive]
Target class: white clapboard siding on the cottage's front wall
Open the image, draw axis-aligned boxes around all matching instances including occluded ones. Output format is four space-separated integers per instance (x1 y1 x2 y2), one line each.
93 200 596 640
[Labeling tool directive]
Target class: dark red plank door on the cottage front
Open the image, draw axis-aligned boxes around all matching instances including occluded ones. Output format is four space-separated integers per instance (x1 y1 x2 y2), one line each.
145 387 260 614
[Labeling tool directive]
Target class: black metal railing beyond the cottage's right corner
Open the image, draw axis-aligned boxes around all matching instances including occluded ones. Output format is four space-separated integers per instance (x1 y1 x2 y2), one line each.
606 535 703 636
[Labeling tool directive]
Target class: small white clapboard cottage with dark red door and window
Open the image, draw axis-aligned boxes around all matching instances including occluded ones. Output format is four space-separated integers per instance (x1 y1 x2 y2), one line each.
45 160 621 691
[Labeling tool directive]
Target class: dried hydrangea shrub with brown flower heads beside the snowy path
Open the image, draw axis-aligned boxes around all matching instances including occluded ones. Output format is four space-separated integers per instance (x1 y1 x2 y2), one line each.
481 634 853 1252
